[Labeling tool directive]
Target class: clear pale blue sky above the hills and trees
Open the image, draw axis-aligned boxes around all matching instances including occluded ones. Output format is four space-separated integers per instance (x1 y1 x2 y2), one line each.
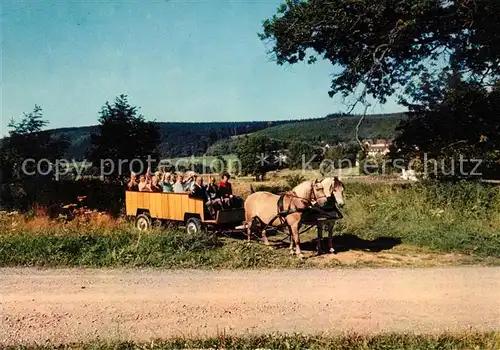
1 0 402 135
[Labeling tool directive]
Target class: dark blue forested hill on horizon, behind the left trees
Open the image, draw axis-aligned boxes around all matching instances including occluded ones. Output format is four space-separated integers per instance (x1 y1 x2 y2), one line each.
47 121 291 160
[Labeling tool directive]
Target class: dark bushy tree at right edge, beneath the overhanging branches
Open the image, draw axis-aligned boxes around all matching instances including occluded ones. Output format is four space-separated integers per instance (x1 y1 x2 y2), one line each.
392 81 500 177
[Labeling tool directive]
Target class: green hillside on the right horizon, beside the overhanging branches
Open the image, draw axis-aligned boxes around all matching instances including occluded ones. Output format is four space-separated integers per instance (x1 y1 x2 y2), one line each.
250 113 404 144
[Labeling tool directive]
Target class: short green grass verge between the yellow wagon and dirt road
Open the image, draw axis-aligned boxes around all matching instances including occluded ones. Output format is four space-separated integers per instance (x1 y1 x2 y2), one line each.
0 229 306 269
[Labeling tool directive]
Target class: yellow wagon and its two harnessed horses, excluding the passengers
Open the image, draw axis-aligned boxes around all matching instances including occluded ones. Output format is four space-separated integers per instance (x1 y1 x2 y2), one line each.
125 179 343 255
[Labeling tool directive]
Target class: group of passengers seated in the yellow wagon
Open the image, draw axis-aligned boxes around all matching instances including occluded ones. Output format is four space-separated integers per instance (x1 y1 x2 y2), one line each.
127 171 243 216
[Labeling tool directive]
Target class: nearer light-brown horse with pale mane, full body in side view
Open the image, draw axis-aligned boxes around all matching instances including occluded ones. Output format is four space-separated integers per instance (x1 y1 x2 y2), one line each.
245 180 328 257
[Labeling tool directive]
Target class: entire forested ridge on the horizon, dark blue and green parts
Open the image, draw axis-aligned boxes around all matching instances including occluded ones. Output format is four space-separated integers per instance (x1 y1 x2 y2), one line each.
42 113 403 160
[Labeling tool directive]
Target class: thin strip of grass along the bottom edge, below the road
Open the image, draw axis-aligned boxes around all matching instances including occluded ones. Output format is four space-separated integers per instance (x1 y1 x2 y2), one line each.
7 333 500 350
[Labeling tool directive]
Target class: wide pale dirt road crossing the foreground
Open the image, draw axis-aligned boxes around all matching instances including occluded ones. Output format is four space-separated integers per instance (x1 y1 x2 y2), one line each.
0 267 500 344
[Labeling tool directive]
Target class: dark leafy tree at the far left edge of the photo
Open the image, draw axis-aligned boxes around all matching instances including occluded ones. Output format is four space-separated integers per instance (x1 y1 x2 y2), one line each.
0 105 69 183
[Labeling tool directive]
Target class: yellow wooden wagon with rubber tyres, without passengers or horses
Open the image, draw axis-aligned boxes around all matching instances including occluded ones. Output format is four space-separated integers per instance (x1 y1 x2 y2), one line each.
125 191 245 233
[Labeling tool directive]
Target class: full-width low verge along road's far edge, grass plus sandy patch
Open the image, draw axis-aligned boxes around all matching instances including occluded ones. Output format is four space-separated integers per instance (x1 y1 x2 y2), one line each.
0 229 500 269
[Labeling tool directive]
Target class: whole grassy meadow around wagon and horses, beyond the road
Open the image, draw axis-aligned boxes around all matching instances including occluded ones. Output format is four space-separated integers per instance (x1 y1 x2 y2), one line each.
0 172 500 268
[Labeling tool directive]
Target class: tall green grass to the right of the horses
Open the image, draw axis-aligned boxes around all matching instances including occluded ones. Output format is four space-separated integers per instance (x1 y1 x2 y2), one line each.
338 183 500 257
